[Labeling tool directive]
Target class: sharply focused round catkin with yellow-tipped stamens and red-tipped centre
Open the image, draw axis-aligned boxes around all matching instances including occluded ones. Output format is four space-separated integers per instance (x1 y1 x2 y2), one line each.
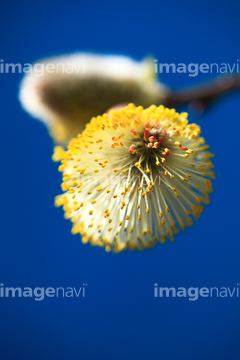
53 104 215 253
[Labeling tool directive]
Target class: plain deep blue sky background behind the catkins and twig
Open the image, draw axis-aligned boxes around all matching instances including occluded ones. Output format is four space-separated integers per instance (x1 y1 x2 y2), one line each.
0 0 240 360
